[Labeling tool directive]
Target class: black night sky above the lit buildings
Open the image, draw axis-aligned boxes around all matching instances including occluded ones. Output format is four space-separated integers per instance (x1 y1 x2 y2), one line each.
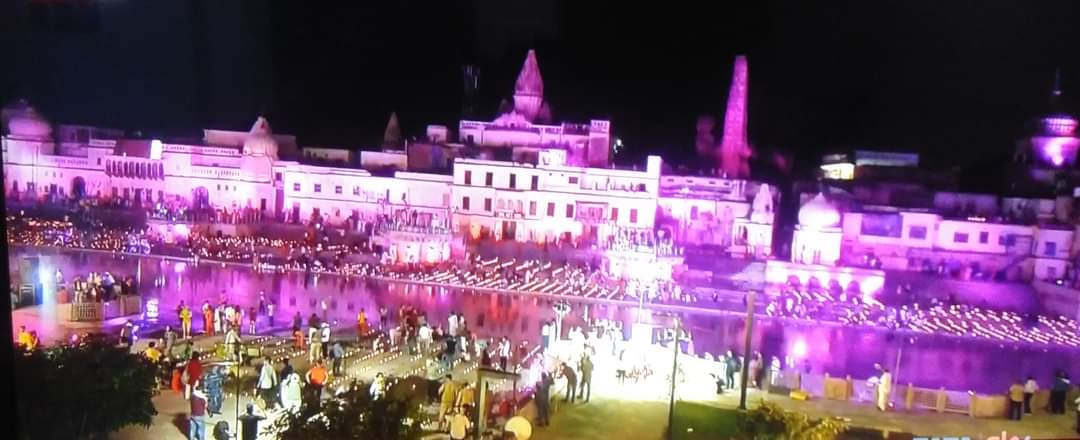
0 0 1080 176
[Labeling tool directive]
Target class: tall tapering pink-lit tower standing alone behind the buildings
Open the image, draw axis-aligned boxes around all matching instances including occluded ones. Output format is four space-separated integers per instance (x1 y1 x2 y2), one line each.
717 55 752 178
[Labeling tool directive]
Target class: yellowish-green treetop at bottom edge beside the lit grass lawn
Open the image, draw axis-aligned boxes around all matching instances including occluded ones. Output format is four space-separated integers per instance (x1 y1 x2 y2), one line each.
737 400 848 440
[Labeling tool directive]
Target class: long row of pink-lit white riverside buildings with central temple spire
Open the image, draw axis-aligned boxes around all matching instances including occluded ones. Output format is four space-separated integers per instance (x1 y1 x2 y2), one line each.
2 51 779 270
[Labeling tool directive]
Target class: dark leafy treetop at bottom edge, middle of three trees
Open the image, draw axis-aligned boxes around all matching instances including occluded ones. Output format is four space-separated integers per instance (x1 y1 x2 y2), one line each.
267 383 421 440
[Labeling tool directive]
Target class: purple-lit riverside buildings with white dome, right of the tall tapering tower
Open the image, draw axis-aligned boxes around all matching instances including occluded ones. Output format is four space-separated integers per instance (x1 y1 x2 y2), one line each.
792 76 1080 285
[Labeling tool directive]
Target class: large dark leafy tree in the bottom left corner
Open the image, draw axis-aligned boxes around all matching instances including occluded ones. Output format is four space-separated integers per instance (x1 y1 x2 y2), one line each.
14 341 158 440
